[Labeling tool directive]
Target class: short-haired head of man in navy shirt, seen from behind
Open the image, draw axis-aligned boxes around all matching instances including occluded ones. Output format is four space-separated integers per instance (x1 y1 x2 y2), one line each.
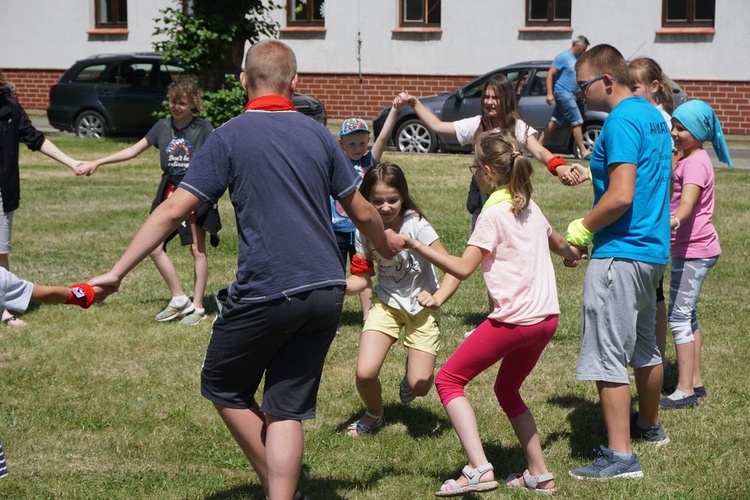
244 40 297 97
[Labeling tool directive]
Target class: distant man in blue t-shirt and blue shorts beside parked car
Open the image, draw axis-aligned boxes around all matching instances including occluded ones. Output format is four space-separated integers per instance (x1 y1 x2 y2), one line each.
539 36 589 160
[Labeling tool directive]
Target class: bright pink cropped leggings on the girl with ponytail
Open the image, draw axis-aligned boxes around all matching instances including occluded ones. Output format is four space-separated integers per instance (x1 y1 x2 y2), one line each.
435 315 557 418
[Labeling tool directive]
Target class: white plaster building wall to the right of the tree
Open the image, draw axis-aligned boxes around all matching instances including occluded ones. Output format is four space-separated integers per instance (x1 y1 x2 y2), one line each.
274 0 750 80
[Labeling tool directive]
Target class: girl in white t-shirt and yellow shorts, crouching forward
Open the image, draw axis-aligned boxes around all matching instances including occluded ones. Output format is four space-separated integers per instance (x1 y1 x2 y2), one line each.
346 163 458 436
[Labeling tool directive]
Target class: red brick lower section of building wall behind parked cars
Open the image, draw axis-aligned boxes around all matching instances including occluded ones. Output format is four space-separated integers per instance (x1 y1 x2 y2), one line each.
3 69 750 135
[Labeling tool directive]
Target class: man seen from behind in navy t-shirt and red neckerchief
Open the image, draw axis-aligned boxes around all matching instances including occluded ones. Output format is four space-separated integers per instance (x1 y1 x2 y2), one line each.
90 40 403 498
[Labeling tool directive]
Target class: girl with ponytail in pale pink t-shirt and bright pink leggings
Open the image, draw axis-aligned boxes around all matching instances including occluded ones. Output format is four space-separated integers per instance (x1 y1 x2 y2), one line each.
404 132 582 497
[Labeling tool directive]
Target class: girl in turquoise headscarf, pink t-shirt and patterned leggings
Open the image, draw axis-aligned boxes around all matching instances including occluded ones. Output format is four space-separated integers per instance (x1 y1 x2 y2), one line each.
659 100 732 409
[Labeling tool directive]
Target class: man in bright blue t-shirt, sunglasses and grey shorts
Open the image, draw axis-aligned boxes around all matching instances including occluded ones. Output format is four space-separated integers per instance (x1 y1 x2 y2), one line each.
568 45 672 479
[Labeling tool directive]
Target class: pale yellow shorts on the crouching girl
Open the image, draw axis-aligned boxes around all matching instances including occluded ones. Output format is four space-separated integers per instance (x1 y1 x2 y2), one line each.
363 294 440 356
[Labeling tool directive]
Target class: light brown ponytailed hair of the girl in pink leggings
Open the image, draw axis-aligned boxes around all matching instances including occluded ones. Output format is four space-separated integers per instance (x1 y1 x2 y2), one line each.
474 130 534 216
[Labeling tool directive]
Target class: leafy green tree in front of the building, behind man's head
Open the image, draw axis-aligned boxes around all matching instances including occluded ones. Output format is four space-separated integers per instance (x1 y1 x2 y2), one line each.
154 0 281 125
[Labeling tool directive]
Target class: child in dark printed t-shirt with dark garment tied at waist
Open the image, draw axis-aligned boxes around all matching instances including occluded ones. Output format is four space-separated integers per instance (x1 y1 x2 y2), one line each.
76 80 221 326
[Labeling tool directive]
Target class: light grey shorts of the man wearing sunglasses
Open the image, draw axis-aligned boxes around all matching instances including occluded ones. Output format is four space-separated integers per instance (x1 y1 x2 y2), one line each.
576 259 666 384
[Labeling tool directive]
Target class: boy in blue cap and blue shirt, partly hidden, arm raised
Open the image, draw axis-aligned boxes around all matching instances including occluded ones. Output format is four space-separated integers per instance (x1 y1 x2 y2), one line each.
331 100 402 322
